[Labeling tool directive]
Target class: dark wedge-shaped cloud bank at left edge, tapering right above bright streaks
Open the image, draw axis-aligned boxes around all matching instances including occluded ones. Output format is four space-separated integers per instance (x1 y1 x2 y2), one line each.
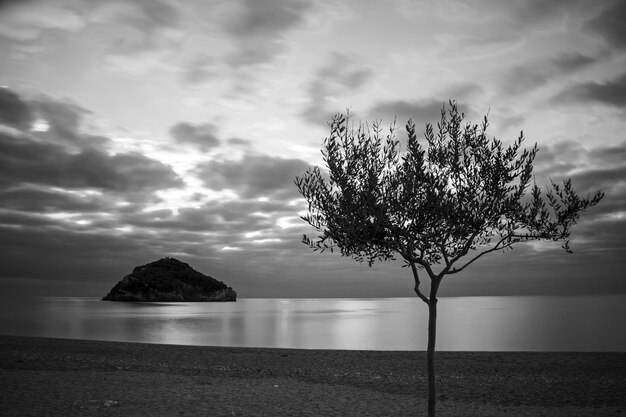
0 89 182 192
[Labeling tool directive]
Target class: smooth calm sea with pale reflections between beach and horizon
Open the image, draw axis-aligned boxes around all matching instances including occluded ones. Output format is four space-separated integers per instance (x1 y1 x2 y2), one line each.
0 295 626 352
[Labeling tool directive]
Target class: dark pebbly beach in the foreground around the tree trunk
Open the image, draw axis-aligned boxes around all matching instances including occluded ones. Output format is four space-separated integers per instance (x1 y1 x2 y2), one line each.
0 336 626 417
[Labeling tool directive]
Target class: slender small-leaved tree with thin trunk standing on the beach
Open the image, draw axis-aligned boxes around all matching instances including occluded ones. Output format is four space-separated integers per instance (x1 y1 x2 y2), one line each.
295 101 604 416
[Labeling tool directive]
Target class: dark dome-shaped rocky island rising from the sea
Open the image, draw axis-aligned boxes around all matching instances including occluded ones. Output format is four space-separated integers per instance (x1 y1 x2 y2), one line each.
102 258 237 301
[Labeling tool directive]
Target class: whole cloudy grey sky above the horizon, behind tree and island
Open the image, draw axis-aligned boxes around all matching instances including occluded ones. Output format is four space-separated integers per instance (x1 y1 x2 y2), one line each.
0 0 626 298
